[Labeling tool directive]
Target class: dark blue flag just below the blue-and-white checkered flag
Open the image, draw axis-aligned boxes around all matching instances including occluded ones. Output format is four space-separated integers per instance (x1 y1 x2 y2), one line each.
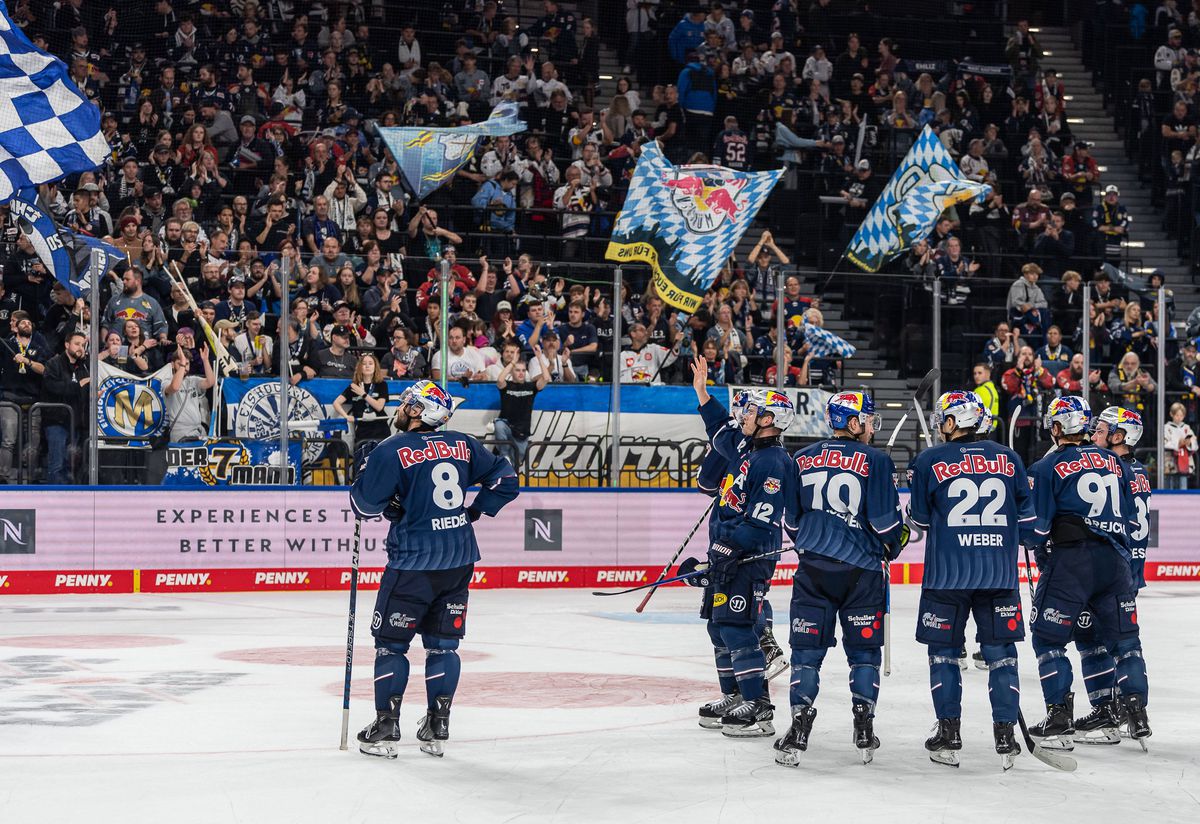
8 190 125 297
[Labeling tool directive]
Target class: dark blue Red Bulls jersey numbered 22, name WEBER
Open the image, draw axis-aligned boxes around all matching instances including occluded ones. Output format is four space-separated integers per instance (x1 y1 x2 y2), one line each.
908 440 1036 589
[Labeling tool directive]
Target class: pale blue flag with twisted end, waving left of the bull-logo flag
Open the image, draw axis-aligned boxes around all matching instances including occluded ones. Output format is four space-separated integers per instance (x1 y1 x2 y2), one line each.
379 101 526 200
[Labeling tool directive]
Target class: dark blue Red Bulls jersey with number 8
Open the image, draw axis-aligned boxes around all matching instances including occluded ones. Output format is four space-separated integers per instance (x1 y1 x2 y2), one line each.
350 432 517 570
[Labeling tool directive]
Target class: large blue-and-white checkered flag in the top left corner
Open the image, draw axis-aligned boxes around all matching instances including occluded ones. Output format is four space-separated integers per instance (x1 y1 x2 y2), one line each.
0 0 109 203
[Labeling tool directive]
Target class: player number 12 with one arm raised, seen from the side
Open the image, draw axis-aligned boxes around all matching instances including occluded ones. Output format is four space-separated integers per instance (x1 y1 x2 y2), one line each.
680 390 796 738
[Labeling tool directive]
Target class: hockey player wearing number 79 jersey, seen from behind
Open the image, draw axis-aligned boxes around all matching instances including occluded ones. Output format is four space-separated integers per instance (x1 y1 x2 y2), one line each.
775 392 907 766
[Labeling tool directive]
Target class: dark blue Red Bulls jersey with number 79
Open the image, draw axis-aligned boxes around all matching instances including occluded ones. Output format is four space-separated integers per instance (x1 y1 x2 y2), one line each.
787 438 902 570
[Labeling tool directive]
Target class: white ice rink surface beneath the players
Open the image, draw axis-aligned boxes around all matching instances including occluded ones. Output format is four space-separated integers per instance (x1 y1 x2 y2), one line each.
0 584 1200 824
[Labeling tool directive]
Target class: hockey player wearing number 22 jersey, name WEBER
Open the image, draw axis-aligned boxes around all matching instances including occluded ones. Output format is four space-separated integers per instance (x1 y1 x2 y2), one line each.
908 392 1034 770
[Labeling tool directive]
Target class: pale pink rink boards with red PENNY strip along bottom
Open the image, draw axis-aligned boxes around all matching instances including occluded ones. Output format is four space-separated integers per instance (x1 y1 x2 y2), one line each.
0 488 1200 595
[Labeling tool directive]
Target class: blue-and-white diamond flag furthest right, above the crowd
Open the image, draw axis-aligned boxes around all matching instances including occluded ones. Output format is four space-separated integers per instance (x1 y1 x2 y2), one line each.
846 126 991 272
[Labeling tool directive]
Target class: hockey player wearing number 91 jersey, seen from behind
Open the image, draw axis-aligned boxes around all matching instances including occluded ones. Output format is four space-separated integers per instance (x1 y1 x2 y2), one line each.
1030 396 1150 750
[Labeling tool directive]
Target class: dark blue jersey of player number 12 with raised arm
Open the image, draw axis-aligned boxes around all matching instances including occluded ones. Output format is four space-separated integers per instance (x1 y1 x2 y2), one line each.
709 440 796 557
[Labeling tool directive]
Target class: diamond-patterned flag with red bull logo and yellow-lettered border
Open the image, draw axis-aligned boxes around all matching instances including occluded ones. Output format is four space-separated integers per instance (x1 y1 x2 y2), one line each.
605 143 784 314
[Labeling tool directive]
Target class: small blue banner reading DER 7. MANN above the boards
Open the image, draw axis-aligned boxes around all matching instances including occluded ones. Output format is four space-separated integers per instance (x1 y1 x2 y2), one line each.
162 438 301 487
